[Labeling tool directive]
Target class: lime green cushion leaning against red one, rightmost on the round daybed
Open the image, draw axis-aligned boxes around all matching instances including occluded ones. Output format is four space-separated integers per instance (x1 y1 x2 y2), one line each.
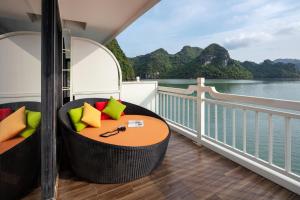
102 97 126 119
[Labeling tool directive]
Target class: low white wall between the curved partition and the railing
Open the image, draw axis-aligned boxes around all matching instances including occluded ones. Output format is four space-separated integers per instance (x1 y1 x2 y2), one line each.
121 81 158 112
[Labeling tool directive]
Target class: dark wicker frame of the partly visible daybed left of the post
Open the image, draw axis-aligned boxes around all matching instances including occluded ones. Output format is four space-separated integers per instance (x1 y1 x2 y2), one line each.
0 102 40 200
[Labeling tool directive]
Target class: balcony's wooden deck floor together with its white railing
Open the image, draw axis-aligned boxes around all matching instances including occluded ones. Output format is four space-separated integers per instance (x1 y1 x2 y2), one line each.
21 78 300 199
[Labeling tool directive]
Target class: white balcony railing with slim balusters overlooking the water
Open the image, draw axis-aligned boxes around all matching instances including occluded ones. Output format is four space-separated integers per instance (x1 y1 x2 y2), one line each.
158 78 300 194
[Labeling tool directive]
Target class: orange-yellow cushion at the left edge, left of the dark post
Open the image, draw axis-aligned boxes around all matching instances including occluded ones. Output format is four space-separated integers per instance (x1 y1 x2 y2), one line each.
0 106 26 142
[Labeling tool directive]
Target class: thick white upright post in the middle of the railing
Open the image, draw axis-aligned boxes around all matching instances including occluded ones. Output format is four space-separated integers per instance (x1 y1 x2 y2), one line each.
197 78 205 144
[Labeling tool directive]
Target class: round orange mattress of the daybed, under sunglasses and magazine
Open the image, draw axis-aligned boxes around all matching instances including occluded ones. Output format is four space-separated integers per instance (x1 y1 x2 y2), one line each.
79 115 169 147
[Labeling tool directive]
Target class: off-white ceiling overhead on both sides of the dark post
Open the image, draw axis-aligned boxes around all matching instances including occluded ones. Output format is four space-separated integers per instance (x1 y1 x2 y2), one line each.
0 0 159 43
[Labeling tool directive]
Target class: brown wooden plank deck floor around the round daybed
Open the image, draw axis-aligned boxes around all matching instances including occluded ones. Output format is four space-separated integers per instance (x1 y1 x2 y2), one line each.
25 133 300 200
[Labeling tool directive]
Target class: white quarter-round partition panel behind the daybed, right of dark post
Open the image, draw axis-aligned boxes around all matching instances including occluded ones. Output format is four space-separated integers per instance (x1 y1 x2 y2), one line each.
71 37 122 99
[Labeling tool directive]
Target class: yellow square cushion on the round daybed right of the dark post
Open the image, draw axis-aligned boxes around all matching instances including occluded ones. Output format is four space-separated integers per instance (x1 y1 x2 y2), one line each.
81 103 101 128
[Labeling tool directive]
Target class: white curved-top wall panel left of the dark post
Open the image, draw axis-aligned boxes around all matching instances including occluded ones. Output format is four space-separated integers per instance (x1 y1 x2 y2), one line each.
0 32 41 103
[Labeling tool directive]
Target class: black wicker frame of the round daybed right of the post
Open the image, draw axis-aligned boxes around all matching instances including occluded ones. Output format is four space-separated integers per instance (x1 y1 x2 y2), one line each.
59 98 170 183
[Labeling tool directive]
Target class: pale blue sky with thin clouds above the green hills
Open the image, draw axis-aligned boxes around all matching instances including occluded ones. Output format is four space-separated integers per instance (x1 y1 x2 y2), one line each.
117 0 300 62
